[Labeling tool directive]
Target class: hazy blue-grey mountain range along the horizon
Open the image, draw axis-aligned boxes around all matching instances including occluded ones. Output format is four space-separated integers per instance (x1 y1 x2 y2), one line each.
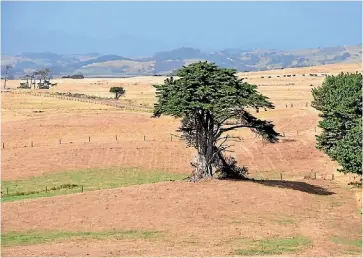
1 45 362 78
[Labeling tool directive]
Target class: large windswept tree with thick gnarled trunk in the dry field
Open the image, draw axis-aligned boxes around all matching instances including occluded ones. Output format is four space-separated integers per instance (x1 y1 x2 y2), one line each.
154 62 279 181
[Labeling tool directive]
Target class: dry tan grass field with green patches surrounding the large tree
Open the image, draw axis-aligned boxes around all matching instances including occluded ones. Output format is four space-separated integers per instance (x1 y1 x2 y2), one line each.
1 64 362 256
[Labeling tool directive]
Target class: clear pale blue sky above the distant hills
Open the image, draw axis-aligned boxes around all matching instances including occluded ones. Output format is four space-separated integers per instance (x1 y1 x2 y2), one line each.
1 1 362 55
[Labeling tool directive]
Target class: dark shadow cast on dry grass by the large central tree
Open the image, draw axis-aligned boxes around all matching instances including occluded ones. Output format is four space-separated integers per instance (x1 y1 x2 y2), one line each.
224 178 335 195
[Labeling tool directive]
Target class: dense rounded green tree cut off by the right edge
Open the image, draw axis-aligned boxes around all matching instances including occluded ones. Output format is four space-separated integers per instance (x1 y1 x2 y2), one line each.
312 73 362 174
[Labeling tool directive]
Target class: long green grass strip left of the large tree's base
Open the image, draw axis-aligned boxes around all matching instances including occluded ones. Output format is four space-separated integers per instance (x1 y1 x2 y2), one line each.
2 168 186 202
